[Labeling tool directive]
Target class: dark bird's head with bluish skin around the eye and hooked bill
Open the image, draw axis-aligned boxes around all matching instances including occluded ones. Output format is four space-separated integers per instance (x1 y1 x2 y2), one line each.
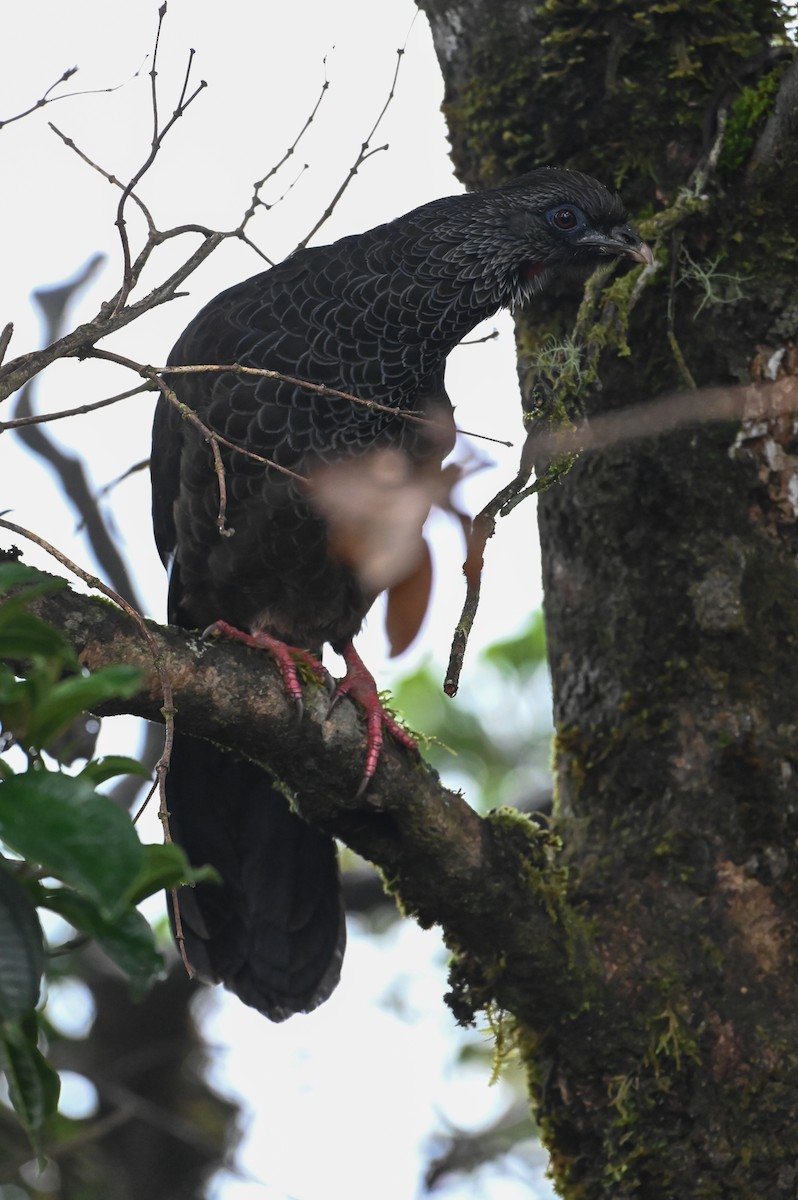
441 167 654 307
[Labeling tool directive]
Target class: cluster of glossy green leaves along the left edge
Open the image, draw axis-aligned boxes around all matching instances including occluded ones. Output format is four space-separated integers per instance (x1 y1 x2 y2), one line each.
0 560 204 1154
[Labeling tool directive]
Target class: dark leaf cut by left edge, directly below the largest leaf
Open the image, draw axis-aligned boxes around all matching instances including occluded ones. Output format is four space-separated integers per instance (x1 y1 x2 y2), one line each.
0 858 44 1021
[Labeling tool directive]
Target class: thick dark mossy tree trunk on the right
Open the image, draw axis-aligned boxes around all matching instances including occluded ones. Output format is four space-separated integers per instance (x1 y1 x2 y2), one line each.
419 0 798 1200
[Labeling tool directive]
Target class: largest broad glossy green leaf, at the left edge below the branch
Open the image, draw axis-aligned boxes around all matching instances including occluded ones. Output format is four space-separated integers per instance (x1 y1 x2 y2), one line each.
0 768 143 914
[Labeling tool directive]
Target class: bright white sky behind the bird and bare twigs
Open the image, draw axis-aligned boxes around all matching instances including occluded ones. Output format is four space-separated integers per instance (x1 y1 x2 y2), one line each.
0 0 551 1200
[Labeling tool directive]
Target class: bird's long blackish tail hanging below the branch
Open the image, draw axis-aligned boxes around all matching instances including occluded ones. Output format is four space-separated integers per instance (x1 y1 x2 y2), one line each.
167 734 346 1021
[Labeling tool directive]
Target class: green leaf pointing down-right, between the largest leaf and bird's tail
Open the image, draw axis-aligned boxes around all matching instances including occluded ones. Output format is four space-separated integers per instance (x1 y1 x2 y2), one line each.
42 888 163 998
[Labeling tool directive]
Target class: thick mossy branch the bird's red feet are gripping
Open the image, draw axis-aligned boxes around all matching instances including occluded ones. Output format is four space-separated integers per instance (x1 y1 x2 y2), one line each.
23 576 598 1030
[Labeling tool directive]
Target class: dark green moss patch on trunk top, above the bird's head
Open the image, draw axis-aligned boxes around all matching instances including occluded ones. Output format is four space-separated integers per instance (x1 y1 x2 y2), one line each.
445 0 780 199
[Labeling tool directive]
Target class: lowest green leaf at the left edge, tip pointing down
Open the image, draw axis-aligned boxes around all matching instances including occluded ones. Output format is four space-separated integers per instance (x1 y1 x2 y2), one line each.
0 1019 61 1156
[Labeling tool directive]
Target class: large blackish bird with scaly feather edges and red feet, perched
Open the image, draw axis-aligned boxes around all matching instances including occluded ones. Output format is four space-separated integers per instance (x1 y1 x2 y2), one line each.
151 167 653 1021
